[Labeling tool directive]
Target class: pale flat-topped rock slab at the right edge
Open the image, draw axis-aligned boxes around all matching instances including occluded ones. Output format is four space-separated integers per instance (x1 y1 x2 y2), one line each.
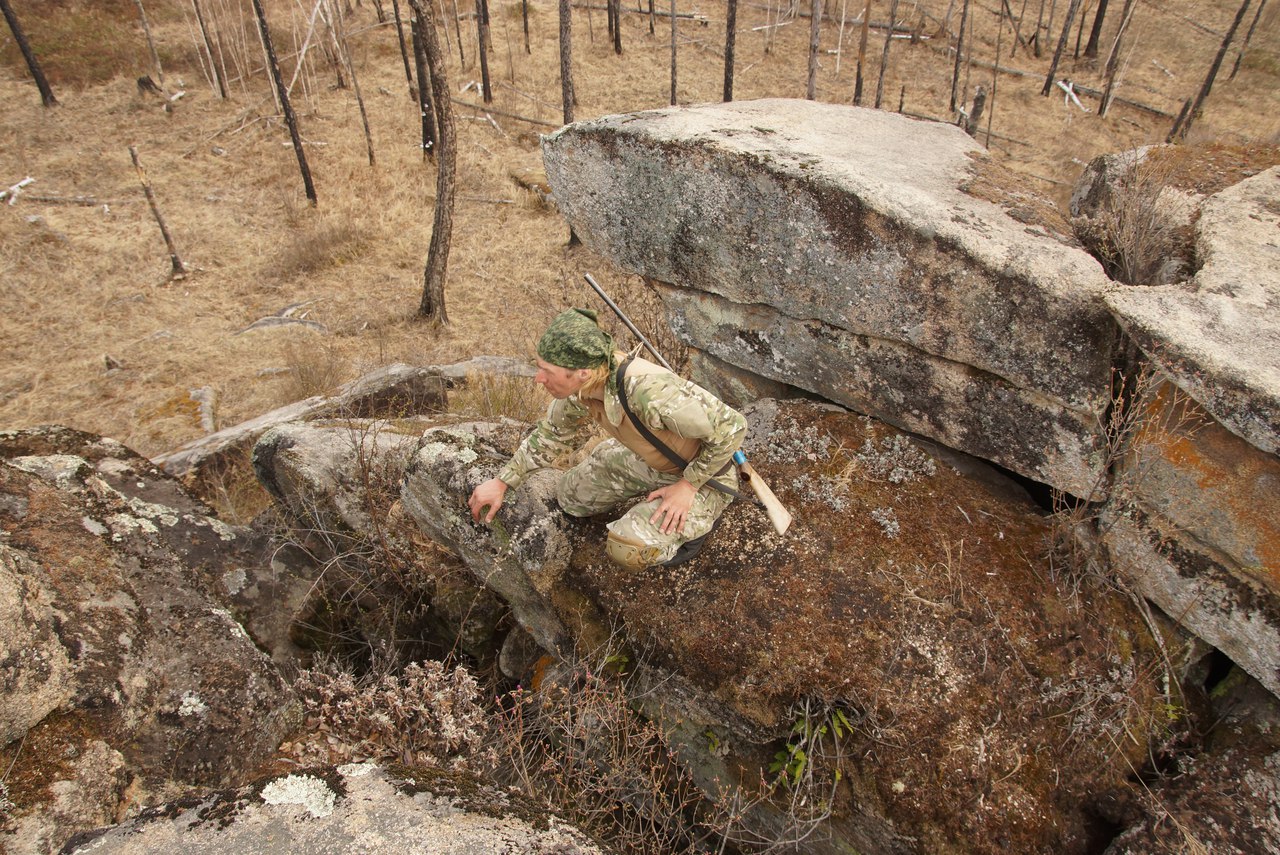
1106 166 1280 454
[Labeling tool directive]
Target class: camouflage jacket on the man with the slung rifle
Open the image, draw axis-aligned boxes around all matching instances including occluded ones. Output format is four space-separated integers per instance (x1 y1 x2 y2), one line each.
498 360 746 488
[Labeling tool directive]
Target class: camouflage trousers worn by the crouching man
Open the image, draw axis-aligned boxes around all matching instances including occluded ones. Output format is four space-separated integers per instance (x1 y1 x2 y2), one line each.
556 439 737 564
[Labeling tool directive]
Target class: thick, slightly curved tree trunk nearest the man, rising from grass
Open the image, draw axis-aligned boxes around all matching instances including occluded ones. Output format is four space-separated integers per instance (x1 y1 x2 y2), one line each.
410 0 458 326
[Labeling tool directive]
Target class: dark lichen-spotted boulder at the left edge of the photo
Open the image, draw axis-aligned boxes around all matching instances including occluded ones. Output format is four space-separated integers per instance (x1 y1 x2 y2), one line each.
0 428 294 852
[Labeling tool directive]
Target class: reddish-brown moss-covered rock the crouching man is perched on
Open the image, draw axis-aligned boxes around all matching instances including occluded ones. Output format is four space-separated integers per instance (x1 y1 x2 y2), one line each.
371 403 1161 852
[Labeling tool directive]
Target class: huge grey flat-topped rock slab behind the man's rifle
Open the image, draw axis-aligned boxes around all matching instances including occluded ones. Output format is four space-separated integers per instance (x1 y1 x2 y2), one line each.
543 100 1119 494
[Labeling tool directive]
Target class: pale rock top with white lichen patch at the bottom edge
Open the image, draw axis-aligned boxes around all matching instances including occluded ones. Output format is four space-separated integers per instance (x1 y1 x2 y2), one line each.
63 763 603 855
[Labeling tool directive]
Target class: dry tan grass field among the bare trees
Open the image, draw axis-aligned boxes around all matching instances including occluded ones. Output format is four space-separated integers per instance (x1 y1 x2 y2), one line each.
0 0 1280 463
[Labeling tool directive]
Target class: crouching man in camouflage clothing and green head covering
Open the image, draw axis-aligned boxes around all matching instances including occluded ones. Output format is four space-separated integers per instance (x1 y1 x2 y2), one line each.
467 308 746 568
